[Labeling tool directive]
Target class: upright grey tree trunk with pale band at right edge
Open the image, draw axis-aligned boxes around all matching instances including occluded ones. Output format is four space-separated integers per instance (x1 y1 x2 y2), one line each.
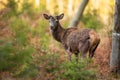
110 0 120 73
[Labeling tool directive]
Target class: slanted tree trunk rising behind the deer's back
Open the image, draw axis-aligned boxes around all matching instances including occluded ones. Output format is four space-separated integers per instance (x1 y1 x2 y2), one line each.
69 0 89 27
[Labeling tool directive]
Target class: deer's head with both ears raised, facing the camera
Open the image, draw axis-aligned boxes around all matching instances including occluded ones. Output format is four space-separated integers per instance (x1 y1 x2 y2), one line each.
43 13 64 30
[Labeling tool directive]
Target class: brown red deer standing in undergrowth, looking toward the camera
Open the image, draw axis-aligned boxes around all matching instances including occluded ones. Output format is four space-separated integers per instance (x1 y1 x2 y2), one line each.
43 14 100 60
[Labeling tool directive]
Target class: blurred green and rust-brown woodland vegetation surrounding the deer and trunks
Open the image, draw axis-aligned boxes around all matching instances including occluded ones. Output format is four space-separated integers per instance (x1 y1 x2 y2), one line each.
0 0 120 80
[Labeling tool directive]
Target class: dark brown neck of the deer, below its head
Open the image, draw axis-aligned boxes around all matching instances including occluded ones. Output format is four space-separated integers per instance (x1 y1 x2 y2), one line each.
51 24 65 42
